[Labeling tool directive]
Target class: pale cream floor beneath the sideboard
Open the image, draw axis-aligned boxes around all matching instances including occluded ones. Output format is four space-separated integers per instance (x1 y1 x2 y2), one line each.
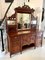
0 36 45 60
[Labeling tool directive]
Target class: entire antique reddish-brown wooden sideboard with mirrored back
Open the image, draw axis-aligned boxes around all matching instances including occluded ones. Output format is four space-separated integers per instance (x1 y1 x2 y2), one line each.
6 5 42 56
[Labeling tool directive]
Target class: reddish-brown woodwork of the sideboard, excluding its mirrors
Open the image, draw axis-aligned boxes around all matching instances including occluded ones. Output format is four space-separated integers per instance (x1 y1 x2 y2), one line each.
6 5 42 55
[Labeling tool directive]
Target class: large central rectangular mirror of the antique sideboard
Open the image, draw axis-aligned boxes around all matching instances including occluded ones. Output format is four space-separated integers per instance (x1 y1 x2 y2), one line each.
17 13 31 30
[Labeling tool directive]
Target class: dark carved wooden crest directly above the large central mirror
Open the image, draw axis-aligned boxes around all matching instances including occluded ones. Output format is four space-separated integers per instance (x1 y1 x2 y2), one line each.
14 5 35 14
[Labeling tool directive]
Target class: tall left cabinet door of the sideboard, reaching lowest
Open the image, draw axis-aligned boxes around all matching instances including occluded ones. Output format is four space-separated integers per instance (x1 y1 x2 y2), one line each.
10 36 20 53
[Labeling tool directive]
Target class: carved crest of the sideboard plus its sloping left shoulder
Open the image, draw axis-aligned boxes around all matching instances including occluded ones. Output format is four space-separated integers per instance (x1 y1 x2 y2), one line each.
8 5 35 19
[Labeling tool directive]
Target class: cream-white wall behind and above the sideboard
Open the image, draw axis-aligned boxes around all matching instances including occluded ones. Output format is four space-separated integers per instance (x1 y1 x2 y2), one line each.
0 0 43 28
